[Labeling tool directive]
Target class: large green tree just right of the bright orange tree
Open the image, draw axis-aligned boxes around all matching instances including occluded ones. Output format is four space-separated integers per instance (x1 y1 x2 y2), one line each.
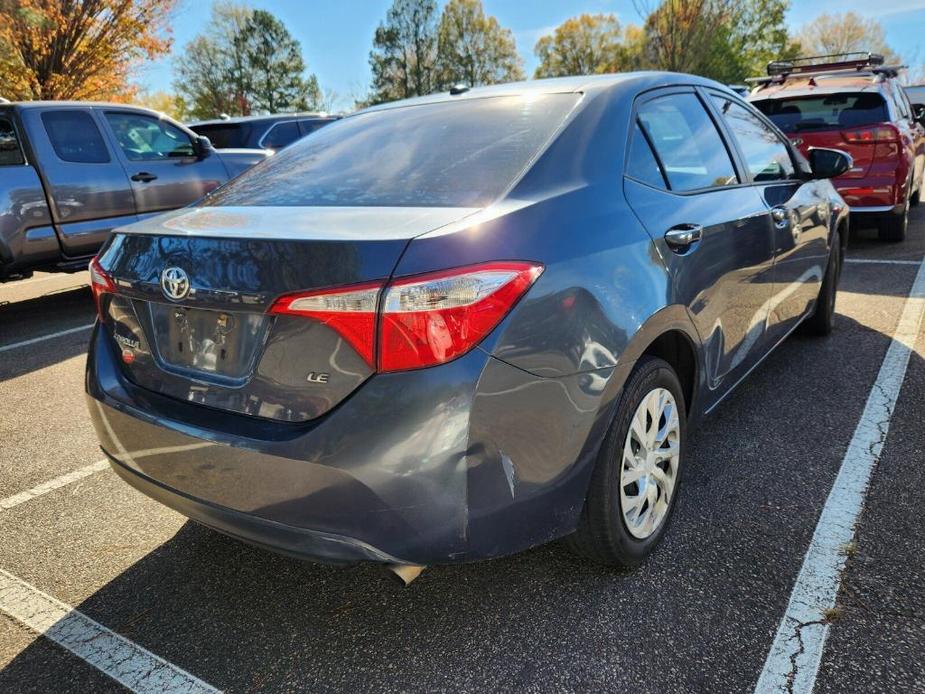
174 2 322 118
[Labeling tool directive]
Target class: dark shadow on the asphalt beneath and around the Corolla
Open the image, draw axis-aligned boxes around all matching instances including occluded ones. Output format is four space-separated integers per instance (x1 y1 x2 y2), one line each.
0 300 921 691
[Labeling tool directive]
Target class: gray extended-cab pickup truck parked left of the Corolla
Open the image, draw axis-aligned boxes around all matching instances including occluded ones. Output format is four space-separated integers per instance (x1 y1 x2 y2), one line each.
0 101 268 281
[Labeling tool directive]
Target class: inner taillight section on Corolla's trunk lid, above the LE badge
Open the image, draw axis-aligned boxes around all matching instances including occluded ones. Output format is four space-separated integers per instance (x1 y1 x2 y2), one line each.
270 283 382 366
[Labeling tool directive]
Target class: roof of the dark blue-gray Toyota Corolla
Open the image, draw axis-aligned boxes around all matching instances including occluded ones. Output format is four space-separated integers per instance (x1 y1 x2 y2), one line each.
360 71 734 115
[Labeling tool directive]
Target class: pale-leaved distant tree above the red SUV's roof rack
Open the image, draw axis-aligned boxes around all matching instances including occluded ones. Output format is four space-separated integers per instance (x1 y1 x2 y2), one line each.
797 12 901 64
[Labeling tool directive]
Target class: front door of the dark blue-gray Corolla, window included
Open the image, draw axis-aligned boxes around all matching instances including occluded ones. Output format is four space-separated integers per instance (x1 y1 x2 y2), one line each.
709 91 832 343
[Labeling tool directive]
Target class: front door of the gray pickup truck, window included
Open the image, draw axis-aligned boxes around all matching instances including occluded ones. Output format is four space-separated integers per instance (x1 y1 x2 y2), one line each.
105 109 228 217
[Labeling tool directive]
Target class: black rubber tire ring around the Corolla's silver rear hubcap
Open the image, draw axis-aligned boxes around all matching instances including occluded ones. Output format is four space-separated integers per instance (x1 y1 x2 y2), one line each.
601 357 687 566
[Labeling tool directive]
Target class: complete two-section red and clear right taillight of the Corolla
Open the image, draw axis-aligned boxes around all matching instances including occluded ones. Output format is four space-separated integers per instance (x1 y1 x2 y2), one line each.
270 261 543 371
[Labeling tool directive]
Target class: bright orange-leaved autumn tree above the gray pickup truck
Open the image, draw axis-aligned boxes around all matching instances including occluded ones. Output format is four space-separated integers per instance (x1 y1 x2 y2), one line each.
0 0 175 101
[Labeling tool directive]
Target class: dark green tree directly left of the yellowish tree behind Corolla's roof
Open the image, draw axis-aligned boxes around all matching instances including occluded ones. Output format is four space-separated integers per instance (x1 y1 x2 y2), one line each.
369 0 438 103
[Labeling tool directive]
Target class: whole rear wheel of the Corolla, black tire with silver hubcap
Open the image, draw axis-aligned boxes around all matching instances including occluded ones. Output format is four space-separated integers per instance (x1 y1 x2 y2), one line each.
566 356 687 568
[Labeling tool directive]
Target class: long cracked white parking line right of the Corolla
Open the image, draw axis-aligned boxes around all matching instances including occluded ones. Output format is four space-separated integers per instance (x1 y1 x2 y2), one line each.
755 261 925 694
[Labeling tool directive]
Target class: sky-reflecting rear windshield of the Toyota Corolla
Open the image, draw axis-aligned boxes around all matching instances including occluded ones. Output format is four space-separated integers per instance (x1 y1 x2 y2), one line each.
203 94 579 207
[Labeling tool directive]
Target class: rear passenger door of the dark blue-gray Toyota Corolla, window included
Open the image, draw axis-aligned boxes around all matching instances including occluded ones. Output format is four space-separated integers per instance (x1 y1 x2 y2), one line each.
624 88 773 407
